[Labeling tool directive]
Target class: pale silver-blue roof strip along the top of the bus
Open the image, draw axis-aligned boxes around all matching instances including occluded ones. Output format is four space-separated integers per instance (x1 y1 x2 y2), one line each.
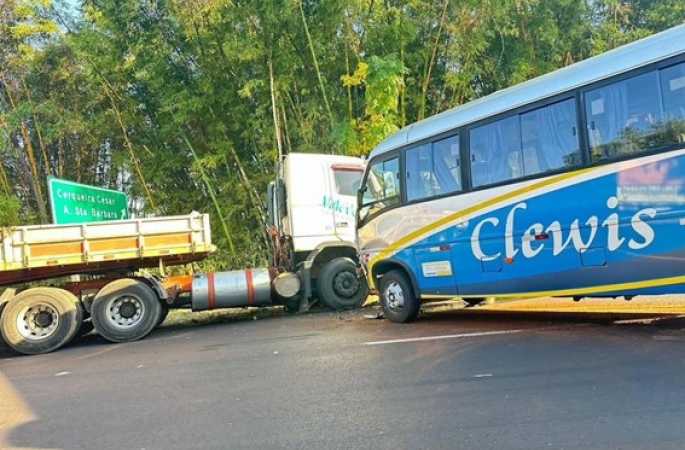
369 25 685 158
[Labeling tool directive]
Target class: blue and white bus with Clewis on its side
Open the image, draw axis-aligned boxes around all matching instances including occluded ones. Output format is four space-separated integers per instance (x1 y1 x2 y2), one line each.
357 25 685 322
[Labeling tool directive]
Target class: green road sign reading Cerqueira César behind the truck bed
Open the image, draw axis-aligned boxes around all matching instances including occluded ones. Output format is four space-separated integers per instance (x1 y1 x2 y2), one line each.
48 177 129 224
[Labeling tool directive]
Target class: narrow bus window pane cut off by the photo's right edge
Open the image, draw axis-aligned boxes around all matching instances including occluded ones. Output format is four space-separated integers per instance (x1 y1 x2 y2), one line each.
659 63 685 144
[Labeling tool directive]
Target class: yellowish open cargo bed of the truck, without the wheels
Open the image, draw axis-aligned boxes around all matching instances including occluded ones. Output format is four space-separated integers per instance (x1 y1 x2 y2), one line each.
0 213 214 286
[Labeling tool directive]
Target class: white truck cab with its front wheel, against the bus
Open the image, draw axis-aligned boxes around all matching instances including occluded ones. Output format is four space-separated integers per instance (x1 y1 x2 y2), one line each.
268 153 368 309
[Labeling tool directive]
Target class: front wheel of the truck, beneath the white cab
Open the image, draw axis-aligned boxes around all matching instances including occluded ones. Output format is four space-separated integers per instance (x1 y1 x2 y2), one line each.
317 258 369 310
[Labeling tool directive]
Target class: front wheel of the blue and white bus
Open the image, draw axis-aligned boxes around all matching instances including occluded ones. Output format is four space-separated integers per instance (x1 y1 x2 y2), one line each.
379 270 421 323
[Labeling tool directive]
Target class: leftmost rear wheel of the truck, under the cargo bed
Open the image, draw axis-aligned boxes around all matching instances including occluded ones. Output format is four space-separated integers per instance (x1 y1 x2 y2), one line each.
0 287 83 355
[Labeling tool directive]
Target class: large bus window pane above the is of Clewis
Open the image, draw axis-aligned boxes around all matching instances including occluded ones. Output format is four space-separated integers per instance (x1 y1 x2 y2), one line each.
585 71 663 161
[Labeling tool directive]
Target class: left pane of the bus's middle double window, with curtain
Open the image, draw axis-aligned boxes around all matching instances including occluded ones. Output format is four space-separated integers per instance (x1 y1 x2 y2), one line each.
469 115 523 187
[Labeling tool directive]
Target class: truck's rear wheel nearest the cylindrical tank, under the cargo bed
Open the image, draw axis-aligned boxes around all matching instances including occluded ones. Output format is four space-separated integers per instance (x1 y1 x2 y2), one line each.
90 278 162 342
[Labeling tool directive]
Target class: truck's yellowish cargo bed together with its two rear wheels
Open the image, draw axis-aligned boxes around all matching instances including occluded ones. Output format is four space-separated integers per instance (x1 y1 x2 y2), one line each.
0 213 215 354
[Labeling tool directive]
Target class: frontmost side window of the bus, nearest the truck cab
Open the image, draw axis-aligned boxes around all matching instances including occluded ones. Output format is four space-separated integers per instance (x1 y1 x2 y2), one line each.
359 157 400 220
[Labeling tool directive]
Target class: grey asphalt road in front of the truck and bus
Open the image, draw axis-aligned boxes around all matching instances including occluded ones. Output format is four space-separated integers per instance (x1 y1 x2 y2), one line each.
0 303 685 450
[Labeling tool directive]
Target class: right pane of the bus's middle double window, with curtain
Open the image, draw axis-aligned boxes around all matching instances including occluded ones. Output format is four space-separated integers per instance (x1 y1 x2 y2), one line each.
521 99 581 171
